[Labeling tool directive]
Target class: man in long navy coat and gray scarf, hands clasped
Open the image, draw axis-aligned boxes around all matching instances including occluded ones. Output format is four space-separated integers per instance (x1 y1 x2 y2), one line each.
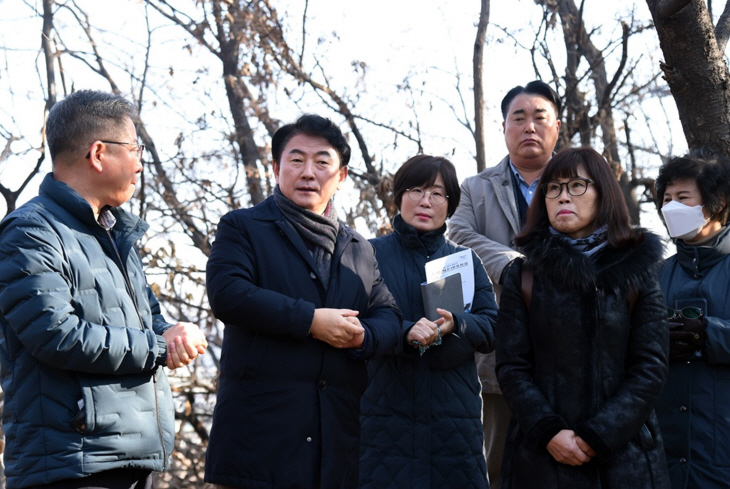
205 115 401 489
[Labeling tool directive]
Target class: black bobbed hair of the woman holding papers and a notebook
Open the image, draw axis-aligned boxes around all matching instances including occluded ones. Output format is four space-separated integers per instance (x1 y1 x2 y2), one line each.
393 155 461 217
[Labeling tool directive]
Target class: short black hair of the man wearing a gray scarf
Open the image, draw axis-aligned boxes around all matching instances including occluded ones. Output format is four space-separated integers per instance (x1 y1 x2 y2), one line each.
271 114 350 166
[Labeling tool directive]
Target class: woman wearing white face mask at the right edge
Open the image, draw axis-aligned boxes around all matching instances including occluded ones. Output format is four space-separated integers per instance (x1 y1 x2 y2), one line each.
656 150 730 489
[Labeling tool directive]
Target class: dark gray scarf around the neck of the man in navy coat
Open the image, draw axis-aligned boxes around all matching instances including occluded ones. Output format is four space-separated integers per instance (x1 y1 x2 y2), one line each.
274 185 340 290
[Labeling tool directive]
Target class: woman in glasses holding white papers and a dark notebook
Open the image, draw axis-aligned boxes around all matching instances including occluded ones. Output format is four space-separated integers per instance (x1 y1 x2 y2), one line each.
360 155 497 489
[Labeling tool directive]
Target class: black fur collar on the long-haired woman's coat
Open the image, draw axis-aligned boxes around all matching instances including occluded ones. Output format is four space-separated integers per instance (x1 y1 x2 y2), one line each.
521 230 663 292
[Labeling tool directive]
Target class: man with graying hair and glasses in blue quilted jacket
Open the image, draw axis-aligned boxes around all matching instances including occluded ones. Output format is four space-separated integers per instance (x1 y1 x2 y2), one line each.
0 90 207 489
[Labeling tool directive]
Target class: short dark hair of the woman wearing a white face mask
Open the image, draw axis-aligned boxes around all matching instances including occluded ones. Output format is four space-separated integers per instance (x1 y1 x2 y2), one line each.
655 147 730 226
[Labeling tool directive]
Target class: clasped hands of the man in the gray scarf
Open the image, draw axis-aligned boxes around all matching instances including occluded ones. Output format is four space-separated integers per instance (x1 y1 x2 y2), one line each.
309 307 365 348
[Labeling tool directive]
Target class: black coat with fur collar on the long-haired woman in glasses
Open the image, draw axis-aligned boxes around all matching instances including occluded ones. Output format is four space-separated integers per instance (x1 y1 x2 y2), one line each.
496 233 669 489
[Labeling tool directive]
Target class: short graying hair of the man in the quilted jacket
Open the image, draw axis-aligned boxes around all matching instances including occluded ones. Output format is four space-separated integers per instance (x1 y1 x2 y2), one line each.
46 90 137 160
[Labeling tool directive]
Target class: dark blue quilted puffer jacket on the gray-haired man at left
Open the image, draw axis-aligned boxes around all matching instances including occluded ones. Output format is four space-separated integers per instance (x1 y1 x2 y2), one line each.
0 174 174 489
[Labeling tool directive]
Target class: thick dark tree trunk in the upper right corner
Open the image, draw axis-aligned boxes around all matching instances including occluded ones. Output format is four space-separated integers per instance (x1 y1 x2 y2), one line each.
646 0 730 155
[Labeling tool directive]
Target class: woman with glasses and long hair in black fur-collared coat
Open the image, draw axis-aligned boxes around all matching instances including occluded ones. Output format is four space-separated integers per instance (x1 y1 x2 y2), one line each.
496 148 669 489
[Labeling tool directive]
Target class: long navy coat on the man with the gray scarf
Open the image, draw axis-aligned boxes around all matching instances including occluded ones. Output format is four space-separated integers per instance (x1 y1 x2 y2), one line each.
205 198 402 489
